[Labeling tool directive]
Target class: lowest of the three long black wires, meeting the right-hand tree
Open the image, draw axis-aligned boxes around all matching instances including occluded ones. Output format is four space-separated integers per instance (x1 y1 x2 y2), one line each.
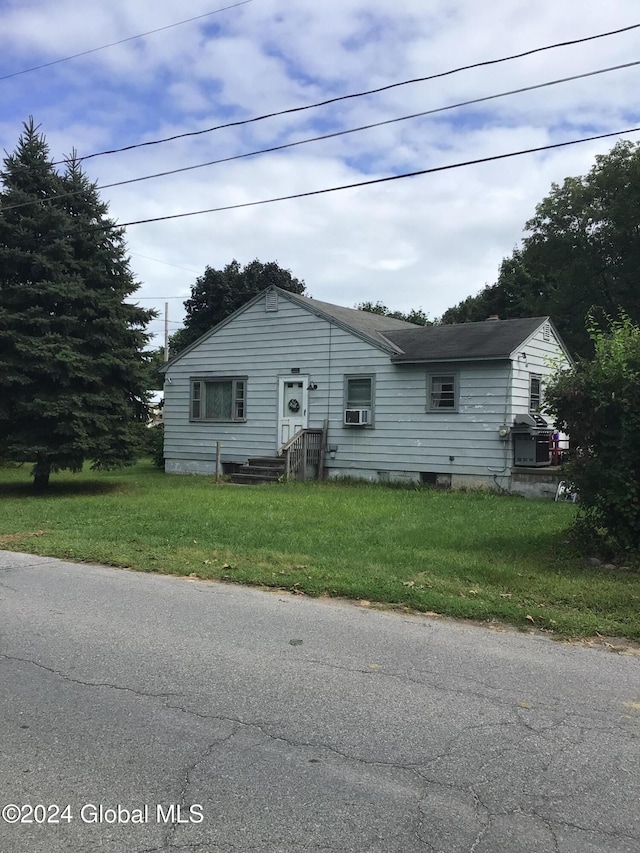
105 127 640 230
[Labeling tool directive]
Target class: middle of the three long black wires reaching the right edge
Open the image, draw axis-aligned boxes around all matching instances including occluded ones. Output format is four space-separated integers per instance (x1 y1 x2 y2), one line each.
3 60 640 213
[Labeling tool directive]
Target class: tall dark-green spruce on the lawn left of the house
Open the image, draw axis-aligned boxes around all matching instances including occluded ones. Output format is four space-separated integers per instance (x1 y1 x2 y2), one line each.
0 119 153 488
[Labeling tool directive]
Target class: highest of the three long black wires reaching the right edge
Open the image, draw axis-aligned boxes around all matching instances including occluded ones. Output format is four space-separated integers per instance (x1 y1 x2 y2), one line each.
61 24 640 165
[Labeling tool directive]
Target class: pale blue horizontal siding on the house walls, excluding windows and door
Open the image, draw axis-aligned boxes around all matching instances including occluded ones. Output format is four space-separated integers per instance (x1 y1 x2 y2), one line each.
164 297 568 477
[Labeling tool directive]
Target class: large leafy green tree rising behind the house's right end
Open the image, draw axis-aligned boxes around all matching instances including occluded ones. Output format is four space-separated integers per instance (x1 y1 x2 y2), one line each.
441 142 640 355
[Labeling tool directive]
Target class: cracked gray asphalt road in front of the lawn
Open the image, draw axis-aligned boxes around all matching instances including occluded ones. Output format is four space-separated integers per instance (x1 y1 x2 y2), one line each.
0 552 640 853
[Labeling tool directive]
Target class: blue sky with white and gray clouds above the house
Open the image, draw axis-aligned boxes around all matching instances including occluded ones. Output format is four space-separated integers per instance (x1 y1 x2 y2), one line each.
0 0 640 345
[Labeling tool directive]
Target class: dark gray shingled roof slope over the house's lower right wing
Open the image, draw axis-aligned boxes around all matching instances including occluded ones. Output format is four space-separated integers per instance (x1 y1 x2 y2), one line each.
385 317 548 361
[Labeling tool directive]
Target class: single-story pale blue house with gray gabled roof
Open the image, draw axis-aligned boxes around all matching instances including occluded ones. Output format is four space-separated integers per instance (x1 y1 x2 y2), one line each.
164 287 571 492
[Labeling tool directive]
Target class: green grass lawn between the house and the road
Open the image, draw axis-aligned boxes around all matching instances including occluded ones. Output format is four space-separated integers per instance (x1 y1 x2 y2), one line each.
0 462 640 639
